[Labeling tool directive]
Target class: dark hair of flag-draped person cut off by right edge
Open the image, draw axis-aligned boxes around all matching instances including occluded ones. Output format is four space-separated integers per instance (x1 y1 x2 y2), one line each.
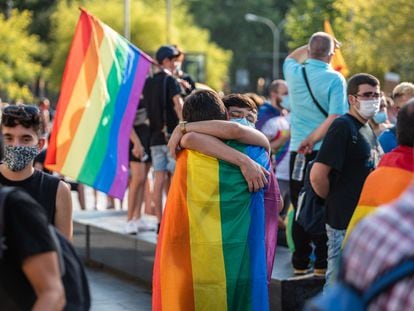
396 98 414 147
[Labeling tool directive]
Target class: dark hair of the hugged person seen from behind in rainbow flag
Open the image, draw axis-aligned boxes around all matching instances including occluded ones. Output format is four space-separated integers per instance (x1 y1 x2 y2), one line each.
183 90 227 122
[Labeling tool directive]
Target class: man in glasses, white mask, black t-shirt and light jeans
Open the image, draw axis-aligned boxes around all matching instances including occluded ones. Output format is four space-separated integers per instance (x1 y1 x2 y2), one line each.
310 73 382 288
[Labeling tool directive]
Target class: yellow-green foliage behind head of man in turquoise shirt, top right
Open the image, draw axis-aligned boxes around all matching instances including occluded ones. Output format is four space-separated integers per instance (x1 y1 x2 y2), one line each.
286 0 414 81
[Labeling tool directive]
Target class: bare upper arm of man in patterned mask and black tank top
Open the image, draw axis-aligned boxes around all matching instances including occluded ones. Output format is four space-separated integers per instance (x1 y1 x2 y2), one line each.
55 181 73 241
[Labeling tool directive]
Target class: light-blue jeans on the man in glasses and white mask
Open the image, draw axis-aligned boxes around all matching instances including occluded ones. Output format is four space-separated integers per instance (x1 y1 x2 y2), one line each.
323 224 346 291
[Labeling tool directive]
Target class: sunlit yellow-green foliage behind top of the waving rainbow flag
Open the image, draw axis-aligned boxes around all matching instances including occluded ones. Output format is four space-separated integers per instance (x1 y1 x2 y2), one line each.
51 0 230 90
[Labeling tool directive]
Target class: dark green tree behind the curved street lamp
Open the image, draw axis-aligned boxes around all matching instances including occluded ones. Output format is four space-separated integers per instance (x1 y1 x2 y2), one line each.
189 0 291 90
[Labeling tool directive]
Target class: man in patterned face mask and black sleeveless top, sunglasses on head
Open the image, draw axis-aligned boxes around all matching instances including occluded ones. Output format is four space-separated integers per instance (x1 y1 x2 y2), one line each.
0 105 72 240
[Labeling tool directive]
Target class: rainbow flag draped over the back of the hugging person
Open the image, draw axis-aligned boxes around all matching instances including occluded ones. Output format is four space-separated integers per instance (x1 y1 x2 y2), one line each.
152 145 278 311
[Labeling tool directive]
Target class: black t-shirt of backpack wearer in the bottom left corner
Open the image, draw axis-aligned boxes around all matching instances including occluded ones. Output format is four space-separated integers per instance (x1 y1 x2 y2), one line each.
0 190 56 310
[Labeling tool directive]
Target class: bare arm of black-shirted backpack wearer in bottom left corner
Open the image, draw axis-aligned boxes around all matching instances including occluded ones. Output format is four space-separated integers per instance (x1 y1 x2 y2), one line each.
22 252 65 311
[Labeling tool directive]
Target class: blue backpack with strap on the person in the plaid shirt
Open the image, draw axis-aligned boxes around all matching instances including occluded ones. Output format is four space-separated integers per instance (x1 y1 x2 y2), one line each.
304 258 414 311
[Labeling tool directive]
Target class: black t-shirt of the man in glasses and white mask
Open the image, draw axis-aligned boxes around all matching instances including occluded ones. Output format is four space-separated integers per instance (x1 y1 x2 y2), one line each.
315 114 381 230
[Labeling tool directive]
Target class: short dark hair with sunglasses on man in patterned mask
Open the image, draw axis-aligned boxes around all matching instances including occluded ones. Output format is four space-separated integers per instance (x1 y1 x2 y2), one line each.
1 105 44 137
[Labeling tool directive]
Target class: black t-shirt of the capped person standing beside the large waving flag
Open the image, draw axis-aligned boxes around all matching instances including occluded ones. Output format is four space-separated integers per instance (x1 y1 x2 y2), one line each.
143 71 181 146
